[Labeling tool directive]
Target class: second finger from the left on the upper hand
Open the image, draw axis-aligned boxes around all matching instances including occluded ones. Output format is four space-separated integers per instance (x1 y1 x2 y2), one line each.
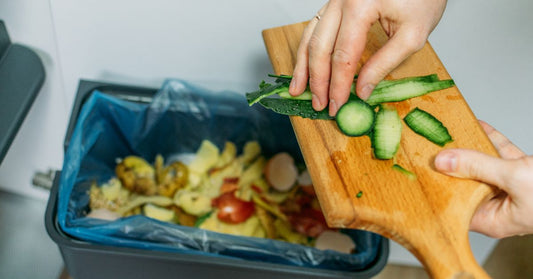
308 1 342 110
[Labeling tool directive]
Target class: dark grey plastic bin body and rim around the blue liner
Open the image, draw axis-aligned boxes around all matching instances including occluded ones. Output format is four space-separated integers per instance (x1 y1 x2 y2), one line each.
45 80 389 279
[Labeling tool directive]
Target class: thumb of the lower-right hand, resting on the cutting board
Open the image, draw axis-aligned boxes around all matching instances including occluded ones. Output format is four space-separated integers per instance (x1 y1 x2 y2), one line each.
435 149 513 192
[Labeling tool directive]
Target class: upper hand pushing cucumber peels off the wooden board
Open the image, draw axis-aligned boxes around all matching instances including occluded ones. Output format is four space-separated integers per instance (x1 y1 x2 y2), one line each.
289 0 446 116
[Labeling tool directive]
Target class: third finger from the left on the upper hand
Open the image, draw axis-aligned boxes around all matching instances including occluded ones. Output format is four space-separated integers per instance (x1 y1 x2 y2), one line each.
329 1 377 116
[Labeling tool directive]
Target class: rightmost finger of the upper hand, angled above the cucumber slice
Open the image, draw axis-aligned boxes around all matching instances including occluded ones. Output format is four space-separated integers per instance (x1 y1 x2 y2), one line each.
356 26 429 100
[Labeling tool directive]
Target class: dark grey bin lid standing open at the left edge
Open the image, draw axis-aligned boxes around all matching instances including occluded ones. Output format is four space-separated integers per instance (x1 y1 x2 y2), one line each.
0 20 45 164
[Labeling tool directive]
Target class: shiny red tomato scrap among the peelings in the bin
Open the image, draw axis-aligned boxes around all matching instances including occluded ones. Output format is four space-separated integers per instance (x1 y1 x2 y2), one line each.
212 191 255 224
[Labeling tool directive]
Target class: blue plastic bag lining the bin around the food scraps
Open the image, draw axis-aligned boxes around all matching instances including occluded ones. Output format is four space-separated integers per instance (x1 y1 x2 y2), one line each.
58 80 382 270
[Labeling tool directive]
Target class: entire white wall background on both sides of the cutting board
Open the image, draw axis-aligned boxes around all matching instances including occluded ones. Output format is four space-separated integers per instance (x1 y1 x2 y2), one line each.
0 0 533 270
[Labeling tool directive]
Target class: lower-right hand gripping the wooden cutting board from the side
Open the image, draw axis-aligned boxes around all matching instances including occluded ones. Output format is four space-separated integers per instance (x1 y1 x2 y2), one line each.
435 121 533 238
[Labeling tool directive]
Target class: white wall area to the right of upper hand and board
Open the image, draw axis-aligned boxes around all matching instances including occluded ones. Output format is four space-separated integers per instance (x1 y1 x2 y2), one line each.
430 0 533 154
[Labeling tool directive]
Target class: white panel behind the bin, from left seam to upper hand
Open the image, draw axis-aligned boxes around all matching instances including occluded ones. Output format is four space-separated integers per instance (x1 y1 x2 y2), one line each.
51 0 323 107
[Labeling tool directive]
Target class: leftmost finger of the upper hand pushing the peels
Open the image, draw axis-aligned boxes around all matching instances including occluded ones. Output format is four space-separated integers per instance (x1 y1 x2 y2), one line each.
289 3 328 96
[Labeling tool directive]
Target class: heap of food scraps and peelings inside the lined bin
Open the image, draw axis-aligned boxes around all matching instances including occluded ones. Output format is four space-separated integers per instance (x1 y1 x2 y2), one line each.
87 140 355 253
